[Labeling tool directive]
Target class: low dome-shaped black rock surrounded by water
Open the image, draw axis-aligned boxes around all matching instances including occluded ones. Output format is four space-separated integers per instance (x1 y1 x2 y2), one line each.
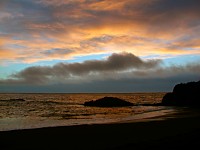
84 97 133 107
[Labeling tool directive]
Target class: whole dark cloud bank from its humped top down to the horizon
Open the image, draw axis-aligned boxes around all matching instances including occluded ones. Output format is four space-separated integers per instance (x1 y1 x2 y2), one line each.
0 53 200 92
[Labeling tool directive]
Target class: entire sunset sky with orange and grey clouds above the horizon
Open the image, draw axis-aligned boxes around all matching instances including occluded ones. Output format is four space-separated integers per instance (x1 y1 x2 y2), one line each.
0 0 200 93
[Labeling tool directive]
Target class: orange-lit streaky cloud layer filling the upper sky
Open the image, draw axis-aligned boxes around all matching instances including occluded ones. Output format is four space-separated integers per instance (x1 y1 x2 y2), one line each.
0 0 200 63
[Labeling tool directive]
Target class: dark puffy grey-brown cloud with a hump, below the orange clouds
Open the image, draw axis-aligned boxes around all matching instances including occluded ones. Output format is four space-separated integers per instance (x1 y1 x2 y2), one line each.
3 53 160 84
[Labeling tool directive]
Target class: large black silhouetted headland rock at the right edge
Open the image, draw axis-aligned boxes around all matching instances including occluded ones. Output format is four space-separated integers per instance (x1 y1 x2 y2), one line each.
162 81 200 106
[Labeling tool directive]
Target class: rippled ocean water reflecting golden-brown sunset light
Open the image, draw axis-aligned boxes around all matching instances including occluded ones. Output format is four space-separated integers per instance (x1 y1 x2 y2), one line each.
0 93 176 131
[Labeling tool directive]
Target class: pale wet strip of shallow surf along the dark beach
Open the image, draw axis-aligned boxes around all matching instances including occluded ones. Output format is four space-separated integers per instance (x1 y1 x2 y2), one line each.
0 108 179 132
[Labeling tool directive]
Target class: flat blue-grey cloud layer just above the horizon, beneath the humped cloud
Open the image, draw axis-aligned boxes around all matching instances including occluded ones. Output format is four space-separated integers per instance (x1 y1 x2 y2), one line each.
0 61 200 93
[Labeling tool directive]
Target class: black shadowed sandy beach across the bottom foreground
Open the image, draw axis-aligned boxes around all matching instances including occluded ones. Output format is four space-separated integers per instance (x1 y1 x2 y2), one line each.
0 108 200 150
